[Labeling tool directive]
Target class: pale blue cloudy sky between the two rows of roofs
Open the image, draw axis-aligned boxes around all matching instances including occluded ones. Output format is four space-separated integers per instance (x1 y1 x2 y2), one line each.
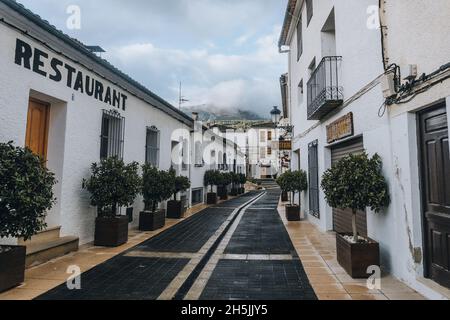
19 0 287 116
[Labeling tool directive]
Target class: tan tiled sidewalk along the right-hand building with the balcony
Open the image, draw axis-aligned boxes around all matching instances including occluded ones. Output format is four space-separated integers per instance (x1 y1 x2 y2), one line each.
278 204 425 300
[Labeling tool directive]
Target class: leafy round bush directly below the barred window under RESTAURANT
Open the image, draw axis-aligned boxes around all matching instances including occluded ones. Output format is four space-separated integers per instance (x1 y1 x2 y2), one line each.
83 157 142 217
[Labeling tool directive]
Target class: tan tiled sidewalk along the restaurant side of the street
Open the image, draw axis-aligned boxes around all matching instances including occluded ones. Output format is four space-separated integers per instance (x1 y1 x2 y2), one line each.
0 205 208 300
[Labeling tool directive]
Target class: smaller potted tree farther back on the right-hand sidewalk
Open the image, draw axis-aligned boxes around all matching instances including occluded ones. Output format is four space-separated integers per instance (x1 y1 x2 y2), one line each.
277 170 308 221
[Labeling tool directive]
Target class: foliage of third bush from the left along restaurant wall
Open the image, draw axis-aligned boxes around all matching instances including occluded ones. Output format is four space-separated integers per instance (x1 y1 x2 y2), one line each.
142 164 175 213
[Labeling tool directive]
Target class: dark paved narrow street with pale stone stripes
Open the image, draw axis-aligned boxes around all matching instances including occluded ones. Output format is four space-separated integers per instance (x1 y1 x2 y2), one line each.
37 188 316 300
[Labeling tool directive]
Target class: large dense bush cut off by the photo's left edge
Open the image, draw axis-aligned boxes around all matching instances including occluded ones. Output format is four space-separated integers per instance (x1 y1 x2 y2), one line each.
0 142 56 240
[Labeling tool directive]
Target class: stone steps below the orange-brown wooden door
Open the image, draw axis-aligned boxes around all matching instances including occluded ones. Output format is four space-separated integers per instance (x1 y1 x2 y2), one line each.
26 237 79 268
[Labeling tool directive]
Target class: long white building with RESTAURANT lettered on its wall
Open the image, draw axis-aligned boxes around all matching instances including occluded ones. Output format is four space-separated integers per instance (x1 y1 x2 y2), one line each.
0 0 245 251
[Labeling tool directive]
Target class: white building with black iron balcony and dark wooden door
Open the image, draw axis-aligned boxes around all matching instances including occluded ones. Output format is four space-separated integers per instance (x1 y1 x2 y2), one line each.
279 0 450 298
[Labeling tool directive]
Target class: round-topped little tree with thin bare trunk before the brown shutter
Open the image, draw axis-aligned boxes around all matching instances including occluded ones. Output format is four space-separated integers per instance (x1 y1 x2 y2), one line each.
321 153 391 242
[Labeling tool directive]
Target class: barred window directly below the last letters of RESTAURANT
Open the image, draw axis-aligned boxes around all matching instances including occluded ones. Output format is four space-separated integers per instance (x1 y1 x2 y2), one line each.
100 110 125 160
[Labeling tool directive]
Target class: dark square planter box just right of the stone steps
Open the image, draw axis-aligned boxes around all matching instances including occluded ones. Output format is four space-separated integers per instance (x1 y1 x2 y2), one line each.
94 216 129 247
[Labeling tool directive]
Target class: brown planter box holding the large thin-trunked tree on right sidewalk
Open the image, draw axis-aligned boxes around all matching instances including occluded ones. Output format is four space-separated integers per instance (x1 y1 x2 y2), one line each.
336 234 380 279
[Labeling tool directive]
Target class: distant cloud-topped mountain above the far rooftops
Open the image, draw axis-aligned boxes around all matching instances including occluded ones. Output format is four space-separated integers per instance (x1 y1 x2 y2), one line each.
181 105 266 121
